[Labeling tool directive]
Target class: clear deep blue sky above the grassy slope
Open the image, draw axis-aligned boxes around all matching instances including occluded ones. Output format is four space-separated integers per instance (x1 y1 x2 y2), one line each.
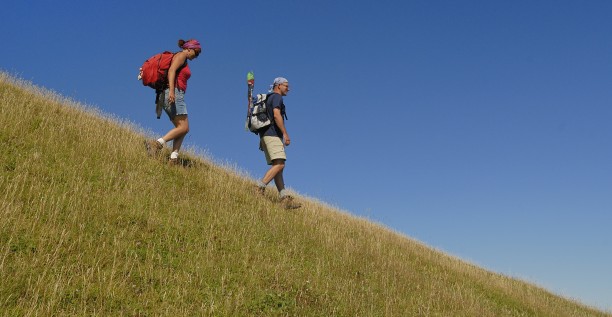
0 0 612 310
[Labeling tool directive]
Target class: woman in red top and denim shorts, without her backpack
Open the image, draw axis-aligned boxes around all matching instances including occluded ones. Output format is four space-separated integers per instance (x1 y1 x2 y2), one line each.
145 39 202 165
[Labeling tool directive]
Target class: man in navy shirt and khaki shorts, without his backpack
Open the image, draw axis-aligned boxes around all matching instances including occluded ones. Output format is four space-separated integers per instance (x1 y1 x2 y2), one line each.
257 77 302 209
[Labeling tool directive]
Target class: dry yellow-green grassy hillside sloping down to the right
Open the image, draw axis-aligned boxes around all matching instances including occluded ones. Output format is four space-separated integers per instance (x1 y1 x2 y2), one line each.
0 73 608 316
